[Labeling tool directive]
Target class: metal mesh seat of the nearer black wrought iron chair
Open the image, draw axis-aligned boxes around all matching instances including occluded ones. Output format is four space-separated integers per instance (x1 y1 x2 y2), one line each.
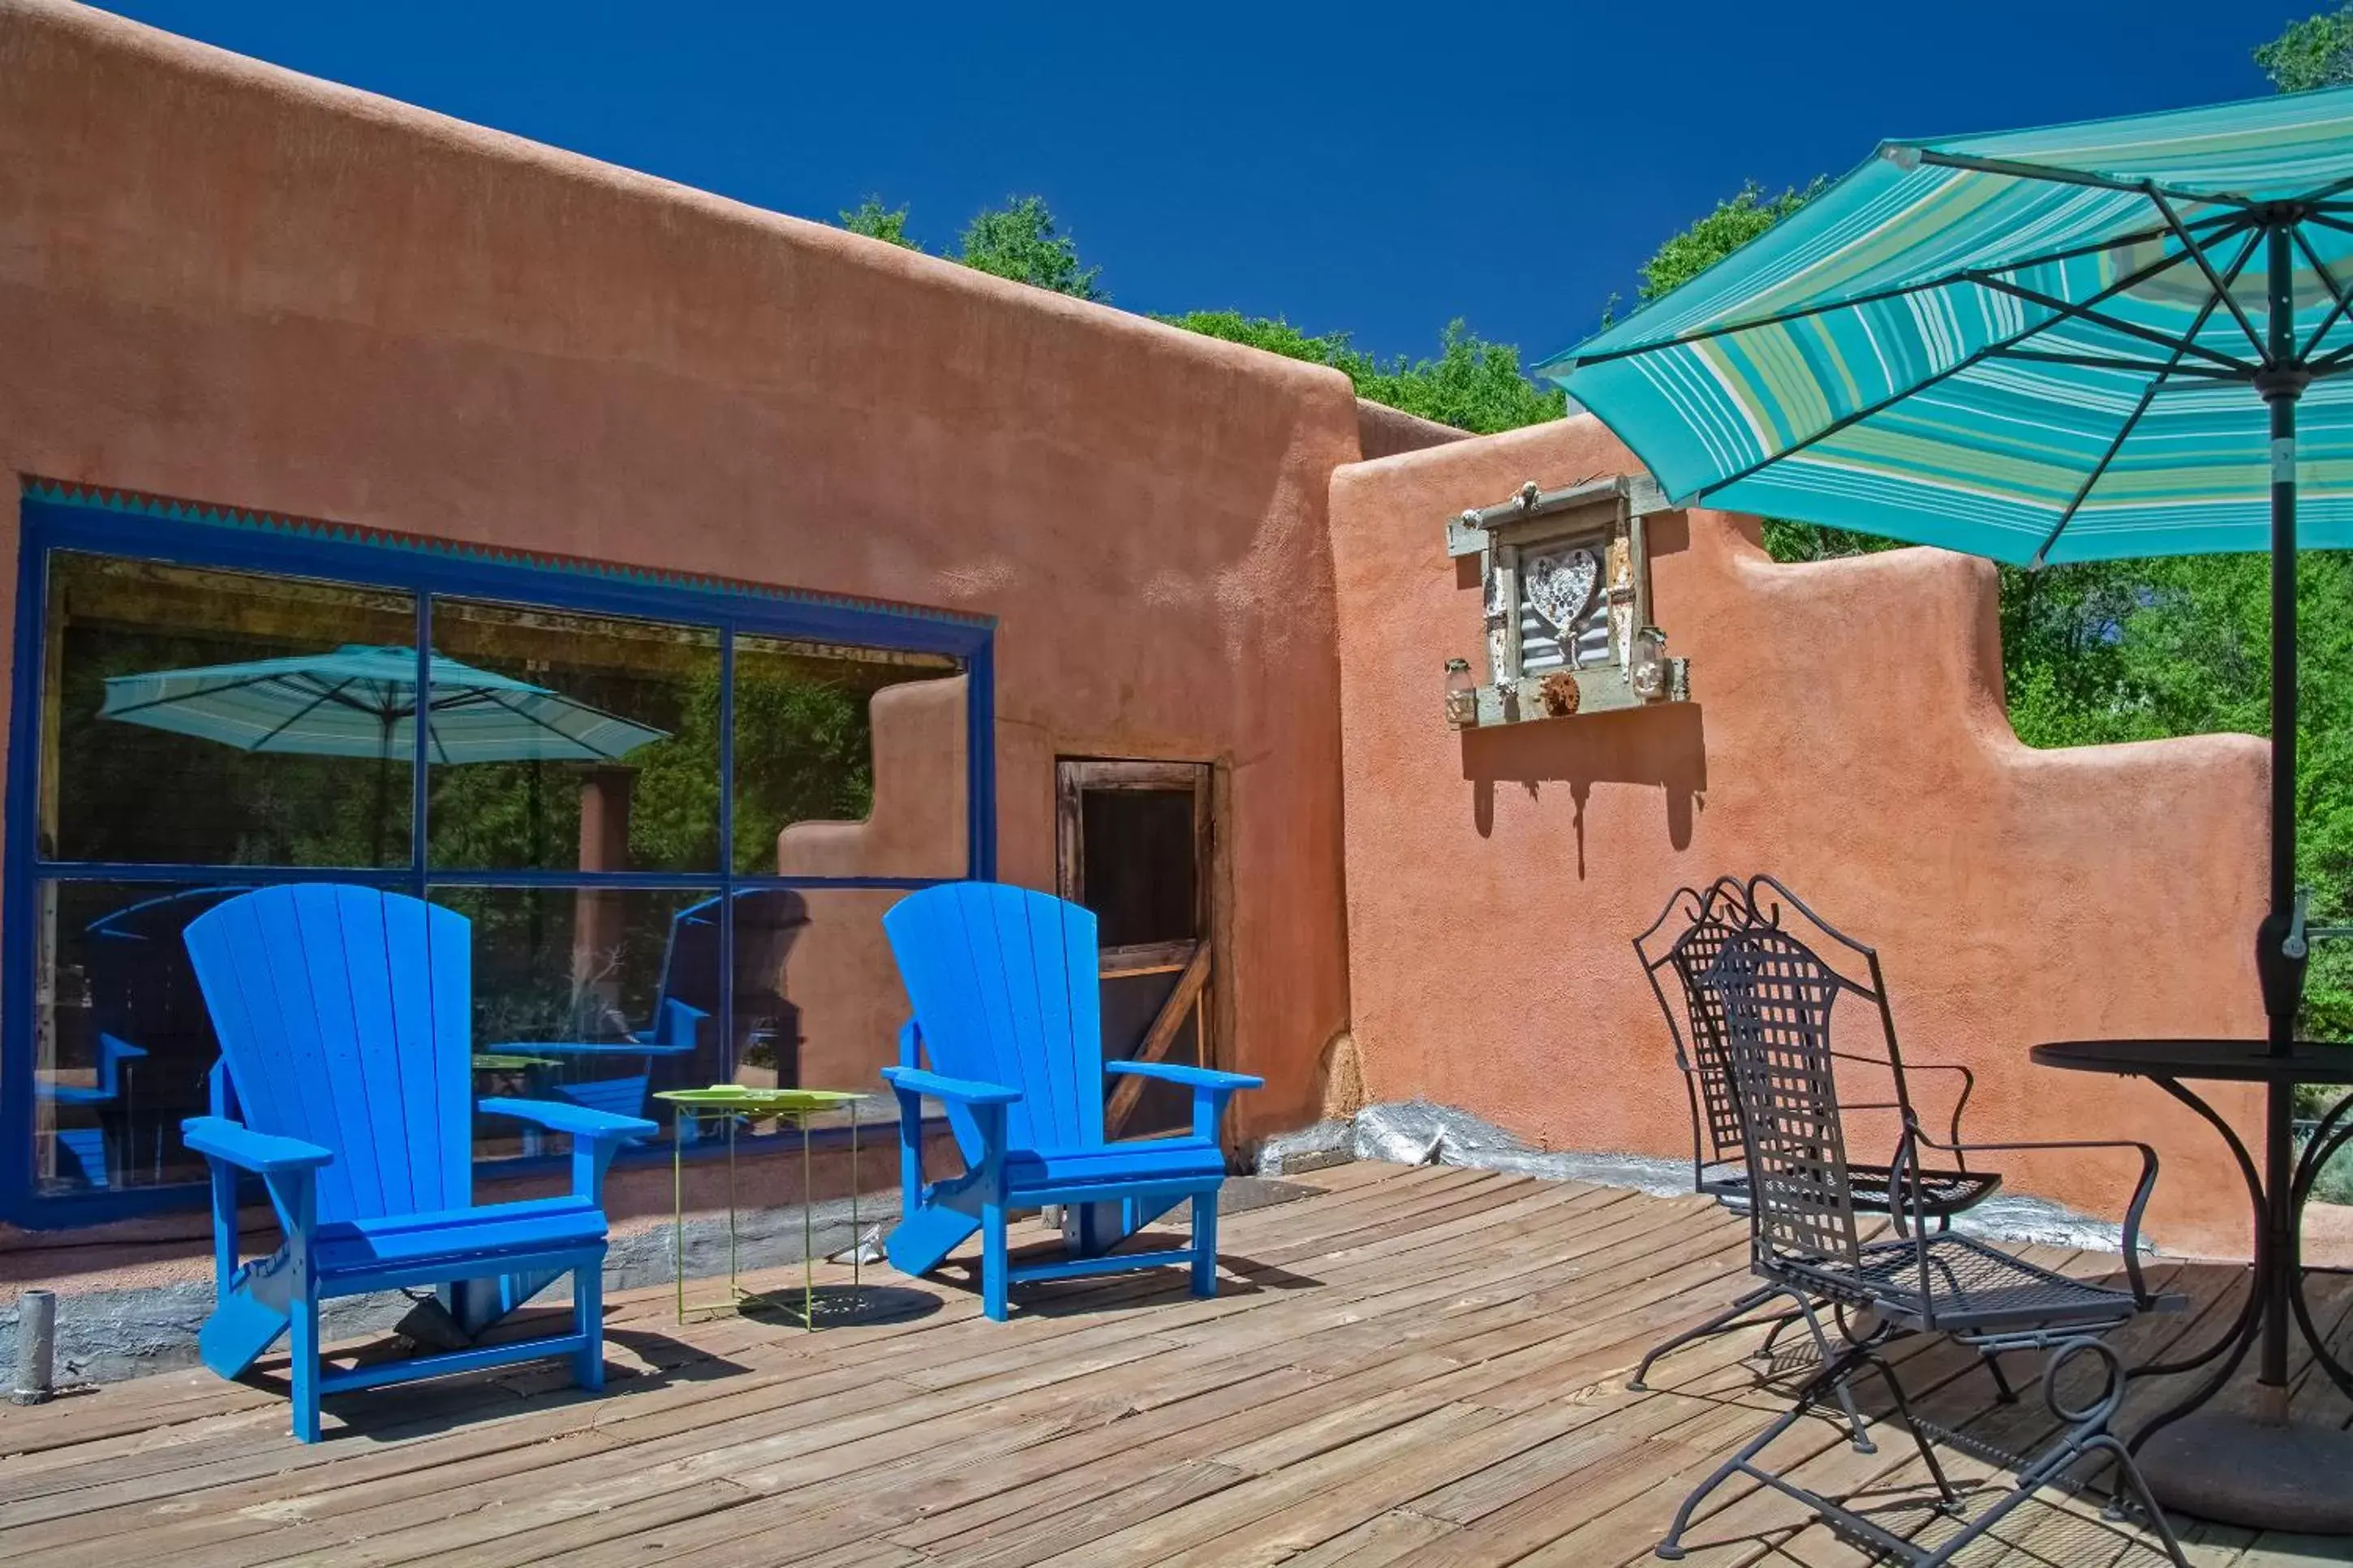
1793 1232 2179 1333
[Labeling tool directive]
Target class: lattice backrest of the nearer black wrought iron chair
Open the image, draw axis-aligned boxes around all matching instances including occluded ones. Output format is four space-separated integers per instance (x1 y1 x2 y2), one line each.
1708 926 1861 1267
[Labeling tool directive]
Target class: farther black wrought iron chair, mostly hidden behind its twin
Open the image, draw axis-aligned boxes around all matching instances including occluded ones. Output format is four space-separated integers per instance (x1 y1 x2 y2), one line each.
1628 872 2002 1410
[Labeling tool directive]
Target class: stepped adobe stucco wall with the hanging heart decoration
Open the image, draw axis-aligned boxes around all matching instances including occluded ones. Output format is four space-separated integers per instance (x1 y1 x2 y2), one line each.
1331 416 2266 1253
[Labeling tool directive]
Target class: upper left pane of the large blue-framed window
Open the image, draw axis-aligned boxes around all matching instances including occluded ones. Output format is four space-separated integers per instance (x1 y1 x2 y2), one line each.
40 550 416 865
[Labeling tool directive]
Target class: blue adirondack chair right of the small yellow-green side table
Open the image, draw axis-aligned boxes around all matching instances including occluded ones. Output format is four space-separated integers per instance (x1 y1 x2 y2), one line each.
883 882 1263 1321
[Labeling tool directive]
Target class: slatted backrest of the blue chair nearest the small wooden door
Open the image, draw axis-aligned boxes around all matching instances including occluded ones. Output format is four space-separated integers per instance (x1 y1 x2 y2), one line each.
883 882 1103 1157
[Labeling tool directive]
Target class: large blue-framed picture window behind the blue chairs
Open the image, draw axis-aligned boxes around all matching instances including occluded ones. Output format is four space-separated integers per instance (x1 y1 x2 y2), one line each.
5 496 988 1225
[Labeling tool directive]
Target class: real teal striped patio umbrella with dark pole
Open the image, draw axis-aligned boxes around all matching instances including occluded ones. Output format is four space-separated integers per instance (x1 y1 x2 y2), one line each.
1539 89 2353 1050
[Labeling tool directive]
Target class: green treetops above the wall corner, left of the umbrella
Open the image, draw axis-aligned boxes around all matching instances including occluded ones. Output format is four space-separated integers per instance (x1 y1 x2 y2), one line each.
1163 311 1567 435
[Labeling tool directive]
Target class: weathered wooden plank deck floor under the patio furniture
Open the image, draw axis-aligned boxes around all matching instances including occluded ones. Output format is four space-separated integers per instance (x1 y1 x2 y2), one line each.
0 1166 2353 1568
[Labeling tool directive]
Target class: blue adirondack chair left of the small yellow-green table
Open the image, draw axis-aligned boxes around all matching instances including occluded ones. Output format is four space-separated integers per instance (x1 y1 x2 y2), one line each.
181 884 656 1443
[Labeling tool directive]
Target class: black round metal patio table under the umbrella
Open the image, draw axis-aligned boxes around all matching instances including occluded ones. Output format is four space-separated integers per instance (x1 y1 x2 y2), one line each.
2031 1039 2353 1533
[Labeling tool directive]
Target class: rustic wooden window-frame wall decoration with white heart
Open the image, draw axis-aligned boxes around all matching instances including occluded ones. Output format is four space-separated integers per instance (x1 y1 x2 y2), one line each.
1448 475 1689 728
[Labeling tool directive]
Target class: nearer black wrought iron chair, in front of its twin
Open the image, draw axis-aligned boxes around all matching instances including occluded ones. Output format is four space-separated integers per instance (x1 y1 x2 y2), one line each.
1657 926 2186 1568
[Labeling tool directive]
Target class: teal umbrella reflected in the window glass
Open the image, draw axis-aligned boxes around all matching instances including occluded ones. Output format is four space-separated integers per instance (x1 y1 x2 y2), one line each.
99 644 669 861
